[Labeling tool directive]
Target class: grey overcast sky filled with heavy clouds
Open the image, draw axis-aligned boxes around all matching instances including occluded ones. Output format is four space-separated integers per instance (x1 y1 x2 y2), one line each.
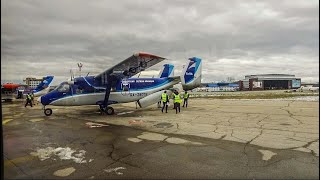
1 0 319 82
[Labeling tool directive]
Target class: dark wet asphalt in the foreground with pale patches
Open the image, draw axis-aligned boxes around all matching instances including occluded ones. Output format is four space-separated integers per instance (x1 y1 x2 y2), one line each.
2 102 319 179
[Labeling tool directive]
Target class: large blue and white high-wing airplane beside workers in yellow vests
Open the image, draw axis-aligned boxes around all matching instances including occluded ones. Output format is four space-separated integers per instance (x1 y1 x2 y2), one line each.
38 52 202 116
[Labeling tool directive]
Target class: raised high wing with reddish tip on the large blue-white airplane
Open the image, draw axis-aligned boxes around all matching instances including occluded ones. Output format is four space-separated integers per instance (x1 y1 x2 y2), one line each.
95 52 165 86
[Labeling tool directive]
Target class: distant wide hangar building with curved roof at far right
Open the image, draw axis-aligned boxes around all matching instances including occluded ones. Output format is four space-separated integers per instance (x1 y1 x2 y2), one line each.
239 74 301 91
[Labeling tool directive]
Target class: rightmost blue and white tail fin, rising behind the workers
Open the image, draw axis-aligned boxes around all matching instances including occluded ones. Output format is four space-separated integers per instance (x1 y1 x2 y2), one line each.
180 57 202 90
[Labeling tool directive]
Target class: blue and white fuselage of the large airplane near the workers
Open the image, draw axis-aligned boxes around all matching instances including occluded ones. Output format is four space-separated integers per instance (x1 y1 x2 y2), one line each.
41 76 180 106
